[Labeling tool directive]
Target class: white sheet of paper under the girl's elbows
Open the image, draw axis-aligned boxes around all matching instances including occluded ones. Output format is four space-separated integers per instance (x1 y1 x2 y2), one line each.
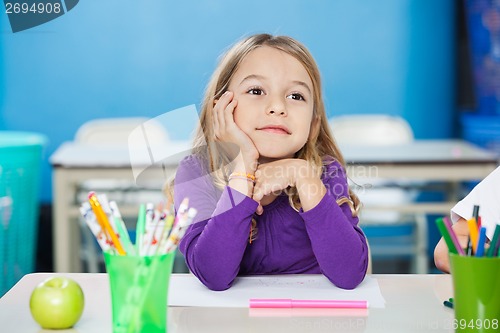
168 274 385 308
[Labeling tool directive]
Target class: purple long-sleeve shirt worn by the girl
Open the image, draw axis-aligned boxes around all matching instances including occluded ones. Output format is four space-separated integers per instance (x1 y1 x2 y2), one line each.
174 155 368 290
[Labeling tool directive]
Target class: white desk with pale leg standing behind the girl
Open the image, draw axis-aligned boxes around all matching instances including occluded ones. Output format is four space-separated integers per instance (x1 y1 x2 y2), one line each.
50 140 497 272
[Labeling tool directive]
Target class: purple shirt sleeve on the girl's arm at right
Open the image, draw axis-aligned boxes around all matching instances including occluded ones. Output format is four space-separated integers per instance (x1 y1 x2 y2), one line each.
300 158 368 289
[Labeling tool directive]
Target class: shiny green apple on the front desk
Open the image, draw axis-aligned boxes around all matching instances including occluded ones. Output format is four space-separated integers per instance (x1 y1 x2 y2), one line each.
30 276 84 329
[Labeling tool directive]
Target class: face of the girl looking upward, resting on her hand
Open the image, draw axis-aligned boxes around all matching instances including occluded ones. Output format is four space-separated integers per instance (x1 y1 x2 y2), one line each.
229 46 314 162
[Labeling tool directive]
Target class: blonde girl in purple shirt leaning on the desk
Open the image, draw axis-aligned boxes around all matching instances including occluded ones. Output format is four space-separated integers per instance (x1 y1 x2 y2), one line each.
174 34 368 290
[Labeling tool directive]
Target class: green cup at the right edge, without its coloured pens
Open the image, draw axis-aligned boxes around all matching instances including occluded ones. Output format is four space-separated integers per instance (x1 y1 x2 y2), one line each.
450 253 500 332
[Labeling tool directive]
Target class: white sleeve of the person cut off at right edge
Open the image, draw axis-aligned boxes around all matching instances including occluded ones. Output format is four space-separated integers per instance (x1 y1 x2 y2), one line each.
451 167 500 240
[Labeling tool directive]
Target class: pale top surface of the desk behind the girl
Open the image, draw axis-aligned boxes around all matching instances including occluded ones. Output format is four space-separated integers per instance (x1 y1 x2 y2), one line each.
50 140 498 168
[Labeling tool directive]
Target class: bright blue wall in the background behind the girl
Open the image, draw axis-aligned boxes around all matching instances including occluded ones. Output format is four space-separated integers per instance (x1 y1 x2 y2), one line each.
0 0 455 202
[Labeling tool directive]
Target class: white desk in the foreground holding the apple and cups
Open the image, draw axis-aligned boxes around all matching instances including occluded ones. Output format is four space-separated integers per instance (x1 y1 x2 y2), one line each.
0 273 454 333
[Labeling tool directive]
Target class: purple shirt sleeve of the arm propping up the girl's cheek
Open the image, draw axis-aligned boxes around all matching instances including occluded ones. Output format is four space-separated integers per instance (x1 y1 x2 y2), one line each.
174 157 258 290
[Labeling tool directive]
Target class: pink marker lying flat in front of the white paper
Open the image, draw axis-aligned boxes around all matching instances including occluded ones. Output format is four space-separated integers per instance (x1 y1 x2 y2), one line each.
250 298 368 309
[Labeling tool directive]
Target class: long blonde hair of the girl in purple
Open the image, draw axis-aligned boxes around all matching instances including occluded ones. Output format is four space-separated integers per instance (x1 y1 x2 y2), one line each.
168 34 359 237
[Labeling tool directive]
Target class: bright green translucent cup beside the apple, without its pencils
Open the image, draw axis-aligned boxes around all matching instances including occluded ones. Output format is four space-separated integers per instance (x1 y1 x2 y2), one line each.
104 253 175 333
